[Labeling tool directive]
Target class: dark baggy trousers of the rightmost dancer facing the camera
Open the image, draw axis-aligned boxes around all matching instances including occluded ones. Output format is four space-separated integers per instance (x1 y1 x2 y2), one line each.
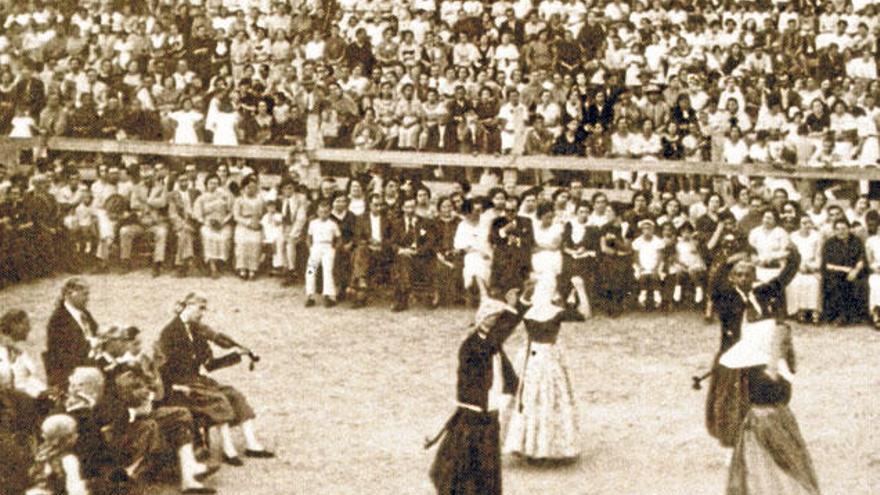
706 364 749 447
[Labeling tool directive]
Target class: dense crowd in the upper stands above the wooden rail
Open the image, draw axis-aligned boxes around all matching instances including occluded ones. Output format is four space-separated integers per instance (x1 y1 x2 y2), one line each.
0 0 880 190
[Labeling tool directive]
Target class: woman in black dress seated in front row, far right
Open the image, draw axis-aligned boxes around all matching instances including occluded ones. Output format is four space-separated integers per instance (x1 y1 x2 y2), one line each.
821 218 868 326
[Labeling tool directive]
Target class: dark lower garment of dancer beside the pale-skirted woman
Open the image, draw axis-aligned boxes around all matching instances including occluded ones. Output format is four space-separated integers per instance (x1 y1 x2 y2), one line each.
430 409 501 495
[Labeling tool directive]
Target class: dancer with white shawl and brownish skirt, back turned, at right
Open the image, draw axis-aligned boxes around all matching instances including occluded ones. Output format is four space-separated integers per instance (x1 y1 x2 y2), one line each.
719 319 820 495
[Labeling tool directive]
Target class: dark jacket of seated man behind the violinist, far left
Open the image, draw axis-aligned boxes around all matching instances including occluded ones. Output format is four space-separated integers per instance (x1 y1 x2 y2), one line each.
43 303 98 389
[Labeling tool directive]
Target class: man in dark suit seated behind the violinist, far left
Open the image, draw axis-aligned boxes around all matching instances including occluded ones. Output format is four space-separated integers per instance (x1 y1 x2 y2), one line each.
43 278 98 390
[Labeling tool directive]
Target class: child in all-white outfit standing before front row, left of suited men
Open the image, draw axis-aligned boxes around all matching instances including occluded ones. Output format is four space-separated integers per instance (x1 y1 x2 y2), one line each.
306 200 342 308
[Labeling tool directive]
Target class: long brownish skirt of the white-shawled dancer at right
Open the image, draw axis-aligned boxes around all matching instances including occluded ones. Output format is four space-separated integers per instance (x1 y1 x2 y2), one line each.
727 405 820 495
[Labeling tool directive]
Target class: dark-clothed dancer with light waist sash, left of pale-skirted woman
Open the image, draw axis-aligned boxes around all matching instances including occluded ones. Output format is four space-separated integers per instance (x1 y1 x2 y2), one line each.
427 289 522 495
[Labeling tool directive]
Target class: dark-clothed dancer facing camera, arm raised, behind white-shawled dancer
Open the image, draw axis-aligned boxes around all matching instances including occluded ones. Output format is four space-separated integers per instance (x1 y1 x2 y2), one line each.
706 245 800 447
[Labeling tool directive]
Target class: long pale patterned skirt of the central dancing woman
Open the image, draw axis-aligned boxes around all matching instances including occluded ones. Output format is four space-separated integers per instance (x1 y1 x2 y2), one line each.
503 342 580 459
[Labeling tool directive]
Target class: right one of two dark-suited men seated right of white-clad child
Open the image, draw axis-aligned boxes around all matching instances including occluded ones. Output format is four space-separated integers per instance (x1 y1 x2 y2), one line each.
390 196 434 311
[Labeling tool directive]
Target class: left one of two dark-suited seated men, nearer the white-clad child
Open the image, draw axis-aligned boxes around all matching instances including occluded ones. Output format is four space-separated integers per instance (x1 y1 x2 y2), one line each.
351 194 391 308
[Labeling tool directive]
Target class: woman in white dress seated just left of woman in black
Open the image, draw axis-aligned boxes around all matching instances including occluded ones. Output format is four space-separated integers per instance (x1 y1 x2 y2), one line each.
785 215 822 322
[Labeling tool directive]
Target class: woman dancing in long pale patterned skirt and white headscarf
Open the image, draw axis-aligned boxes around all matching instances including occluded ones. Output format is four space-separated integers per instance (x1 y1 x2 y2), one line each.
503 276 580 460
